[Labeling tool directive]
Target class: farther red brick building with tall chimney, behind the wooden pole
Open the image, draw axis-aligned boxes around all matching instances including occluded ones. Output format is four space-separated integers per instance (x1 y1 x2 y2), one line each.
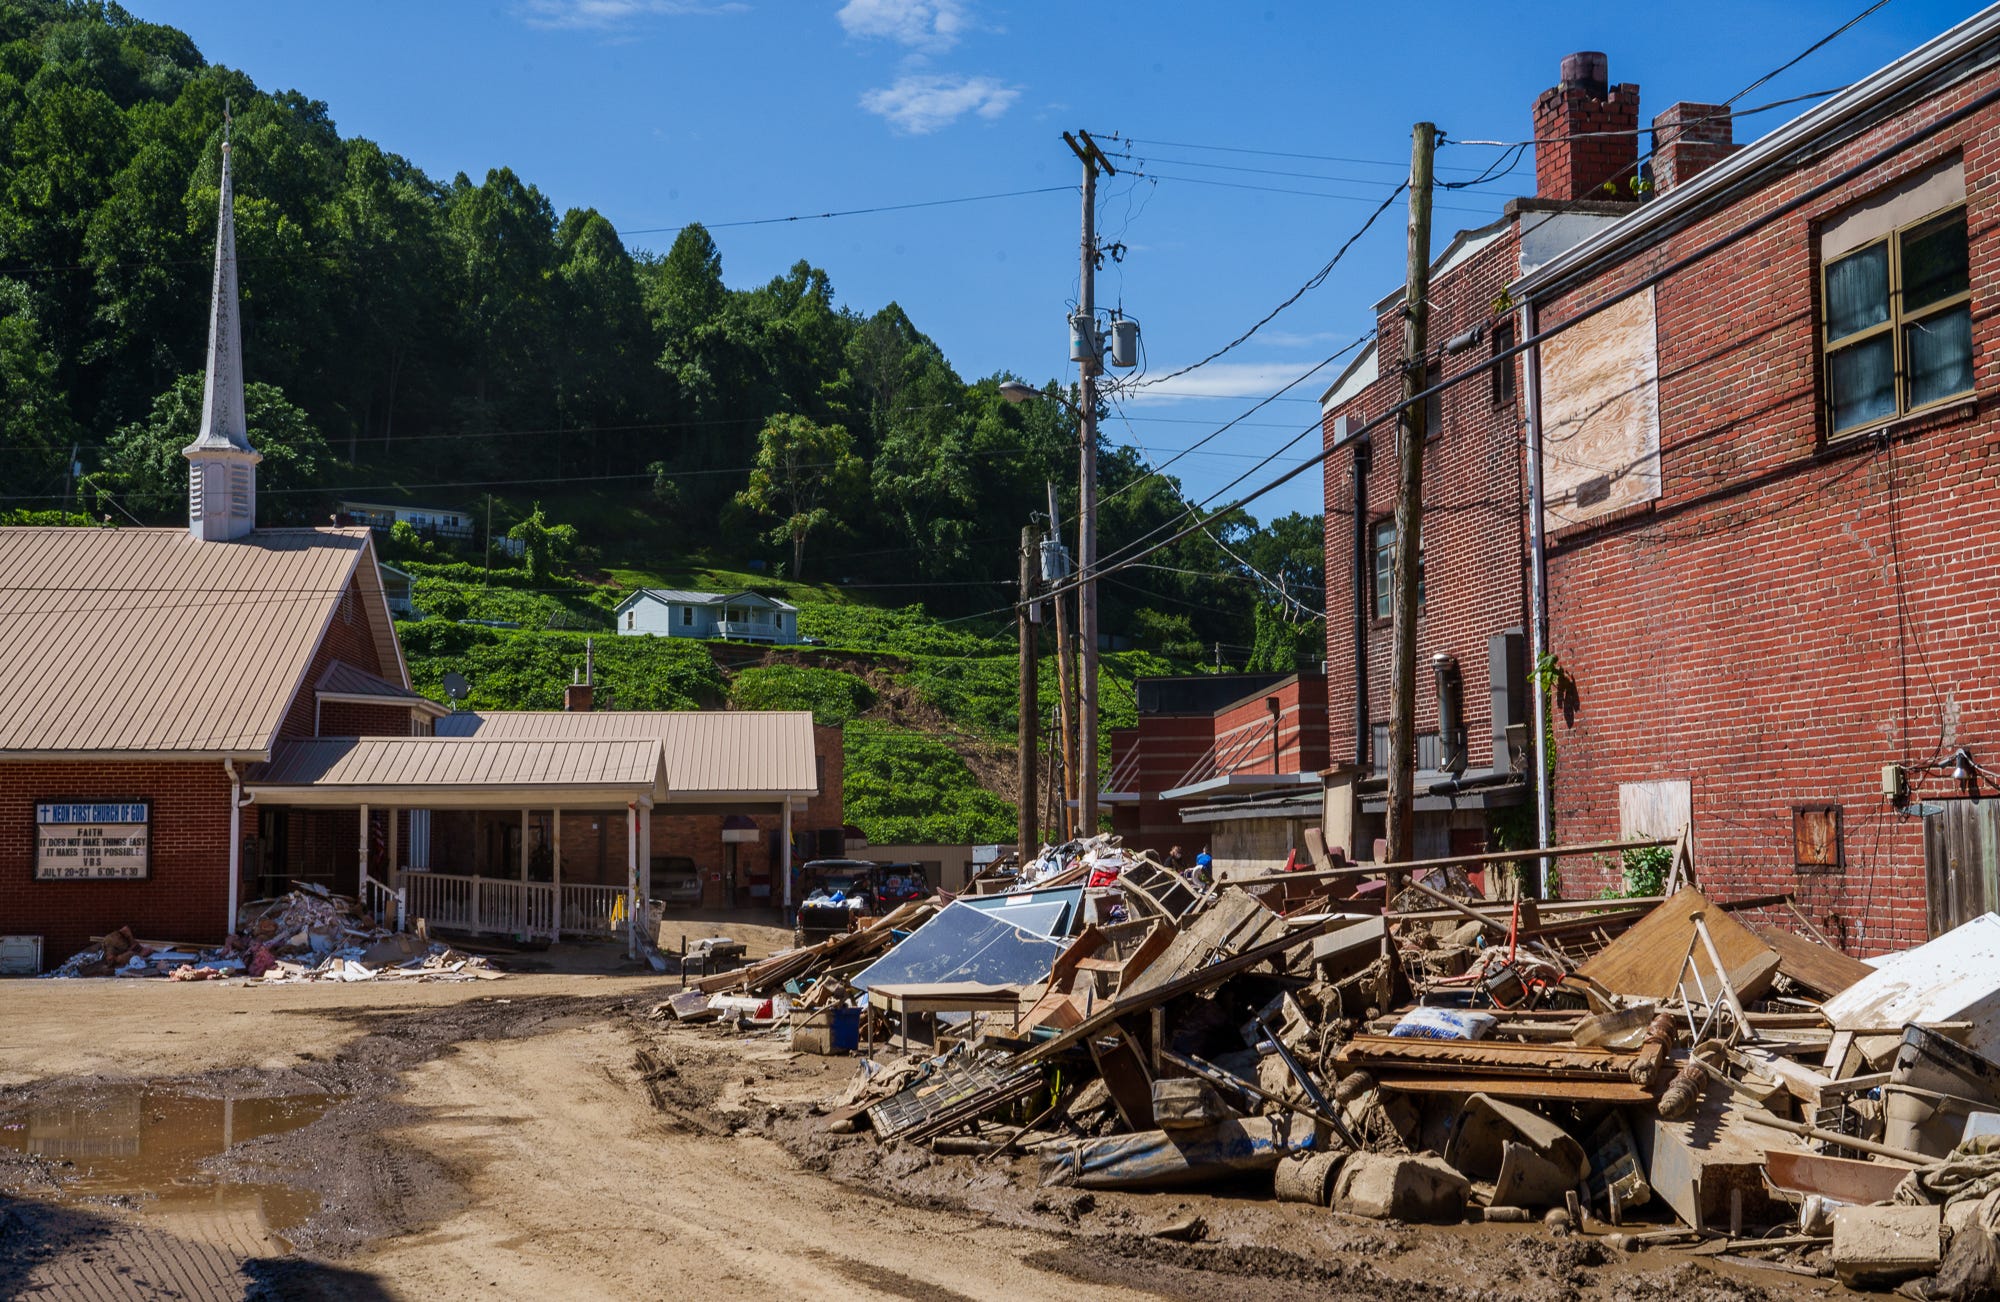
1320 54 1638 860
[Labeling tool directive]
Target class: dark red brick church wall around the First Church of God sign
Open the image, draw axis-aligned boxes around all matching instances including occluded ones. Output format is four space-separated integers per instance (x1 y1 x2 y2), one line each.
0 760 230 966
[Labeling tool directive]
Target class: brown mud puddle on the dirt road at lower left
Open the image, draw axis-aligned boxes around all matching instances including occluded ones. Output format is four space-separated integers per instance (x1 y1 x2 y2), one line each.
0 1084 338 1252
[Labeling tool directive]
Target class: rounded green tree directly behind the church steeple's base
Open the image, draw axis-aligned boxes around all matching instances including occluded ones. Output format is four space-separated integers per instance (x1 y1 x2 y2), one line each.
104 372 332 524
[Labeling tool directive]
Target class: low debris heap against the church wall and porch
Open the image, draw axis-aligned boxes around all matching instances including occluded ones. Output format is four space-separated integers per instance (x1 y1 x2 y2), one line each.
48 882 500 986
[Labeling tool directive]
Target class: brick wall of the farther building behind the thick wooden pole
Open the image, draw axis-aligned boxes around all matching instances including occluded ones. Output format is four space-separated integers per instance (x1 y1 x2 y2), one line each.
1324 227 1538 768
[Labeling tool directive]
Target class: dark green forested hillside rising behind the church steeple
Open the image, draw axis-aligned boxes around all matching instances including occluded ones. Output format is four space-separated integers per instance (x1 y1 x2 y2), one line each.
0 0 1320 664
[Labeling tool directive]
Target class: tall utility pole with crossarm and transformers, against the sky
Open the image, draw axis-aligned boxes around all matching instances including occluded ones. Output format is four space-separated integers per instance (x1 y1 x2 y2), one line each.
1062 130 1118 836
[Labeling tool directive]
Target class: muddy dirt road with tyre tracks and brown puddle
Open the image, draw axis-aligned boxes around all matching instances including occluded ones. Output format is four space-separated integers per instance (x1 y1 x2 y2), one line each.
0 974 1838 1302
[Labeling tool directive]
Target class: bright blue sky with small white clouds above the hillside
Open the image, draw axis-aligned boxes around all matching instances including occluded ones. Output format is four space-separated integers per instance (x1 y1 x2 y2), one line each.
126 0 1978 516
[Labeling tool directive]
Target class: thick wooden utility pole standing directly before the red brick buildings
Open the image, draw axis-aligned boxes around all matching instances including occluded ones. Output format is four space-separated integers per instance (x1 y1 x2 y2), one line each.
1384 122 1438 908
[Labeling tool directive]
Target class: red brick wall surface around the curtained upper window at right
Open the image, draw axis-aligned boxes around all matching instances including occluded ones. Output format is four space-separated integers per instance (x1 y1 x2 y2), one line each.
1542 72 2000 954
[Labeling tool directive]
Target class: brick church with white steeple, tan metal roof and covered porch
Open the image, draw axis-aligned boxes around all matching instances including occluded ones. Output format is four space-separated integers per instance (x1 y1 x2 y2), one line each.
0 132 824 958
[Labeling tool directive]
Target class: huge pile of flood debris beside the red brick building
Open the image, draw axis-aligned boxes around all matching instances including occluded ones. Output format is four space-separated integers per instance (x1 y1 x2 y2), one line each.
660 836 2000 1298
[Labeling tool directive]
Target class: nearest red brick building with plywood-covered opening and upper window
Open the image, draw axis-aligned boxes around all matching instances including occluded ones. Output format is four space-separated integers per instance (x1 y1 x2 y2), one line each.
1504 12 2000 954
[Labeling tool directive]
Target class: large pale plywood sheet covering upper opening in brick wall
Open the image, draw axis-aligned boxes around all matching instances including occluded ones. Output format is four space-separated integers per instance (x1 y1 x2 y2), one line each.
1542 290 1660 530
